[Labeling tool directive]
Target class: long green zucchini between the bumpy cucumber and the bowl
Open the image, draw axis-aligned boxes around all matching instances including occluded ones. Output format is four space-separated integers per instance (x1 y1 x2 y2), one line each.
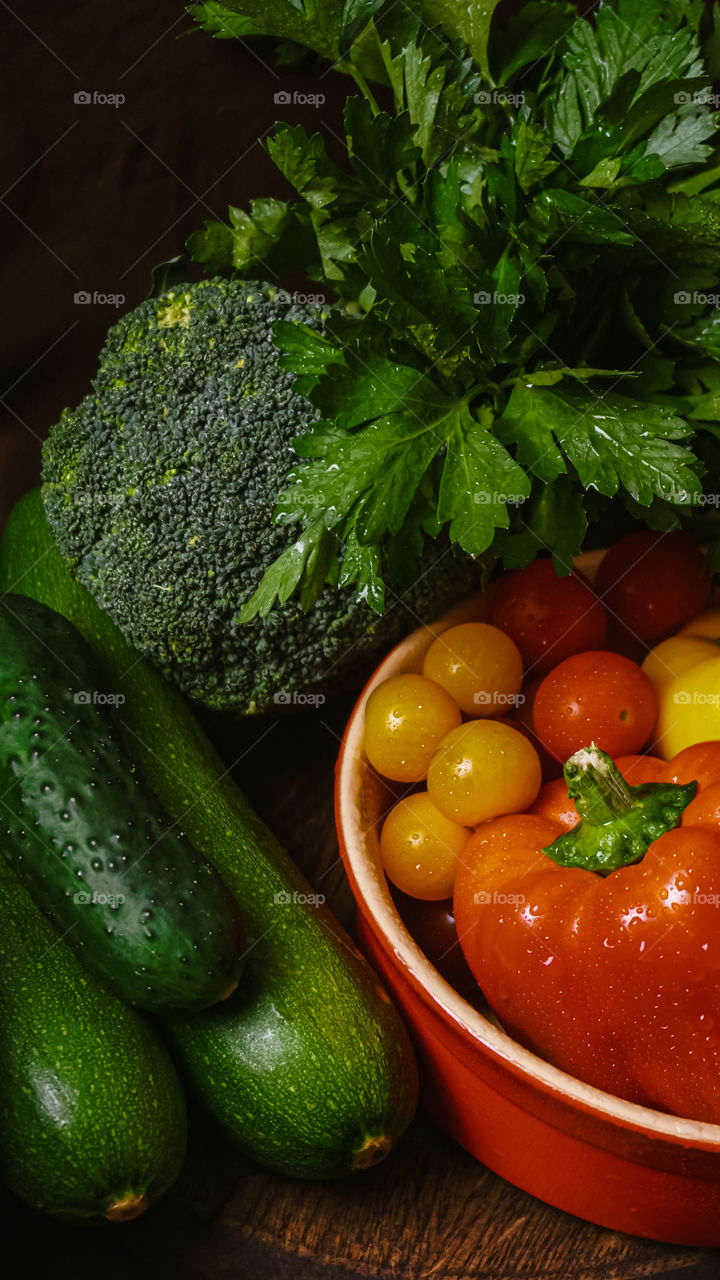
0 493 418 1178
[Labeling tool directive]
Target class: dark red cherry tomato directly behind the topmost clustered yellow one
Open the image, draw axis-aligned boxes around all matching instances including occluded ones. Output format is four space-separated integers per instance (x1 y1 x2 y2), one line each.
491 559 607 675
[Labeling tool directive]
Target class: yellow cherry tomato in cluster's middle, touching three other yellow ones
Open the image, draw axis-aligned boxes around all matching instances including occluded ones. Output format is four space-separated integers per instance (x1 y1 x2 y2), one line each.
428 721 542 827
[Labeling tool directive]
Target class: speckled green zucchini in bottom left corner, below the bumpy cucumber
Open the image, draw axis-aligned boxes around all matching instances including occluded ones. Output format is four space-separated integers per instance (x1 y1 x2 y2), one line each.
0 860 187 1220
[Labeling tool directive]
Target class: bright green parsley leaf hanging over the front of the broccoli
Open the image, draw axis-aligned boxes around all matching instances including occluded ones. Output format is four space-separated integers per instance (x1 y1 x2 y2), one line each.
238 362 530 620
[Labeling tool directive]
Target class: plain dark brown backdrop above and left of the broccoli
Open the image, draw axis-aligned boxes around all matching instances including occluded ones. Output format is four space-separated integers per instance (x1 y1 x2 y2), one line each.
0 0 347 524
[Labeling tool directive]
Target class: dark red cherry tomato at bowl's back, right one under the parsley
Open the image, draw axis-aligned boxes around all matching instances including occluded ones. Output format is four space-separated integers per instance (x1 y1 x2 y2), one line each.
596 529 711 645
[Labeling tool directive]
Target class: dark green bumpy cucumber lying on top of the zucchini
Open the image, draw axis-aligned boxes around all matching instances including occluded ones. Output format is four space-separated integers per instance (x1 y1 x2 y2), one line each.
0 595 242 1012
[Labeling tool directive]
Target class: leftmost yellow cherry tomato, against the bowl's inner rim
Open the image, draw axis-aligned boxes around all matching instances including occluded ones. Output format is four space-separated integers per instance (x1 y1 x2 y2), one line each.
365 676 462 782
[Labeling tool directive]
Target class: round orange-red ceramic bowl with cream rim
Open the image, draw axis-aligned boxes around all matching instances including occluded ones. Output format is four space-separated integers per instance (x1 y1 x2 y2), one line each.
336 553 720 1245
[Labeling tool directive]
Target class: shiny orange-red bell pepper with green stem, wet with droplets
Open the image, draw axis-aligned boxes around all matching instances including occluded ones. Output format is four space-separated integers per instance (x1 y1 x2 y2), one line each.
455 742 720 1123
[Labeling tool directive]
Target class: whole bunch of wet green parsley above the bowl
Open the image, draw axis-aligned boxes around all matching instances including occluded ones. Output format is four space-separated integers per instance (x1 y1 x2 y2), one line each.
188 0 720 622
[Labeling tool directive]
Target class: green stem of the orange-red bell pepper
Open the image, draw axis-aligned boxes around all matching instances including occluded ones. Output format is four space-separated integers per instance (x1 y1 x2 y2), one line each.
543 744 697 876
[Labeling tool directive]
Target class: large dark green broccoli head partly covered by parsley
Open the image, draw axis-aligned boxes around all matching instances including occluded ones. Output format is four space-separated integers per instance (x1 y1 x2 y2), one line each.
42 279 477 713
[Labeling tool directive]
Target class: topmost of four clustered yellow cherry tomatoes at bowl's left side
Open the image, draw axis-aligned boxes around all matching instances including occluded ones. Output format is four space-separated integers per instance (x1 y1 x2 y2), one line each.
423 622 523 716
